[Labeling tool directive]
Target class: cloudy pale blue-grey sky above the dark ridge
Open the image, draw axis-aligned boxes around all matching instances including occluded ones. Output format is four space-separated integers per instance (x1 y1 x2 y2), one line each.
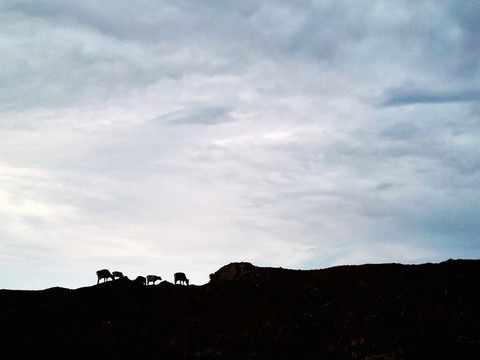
0 0 480 290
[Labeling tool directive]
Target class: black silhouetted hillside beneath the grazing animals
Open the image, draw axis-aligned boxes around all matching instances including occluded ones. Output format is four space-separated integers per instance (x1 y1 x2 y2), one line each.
0 260 480 360
